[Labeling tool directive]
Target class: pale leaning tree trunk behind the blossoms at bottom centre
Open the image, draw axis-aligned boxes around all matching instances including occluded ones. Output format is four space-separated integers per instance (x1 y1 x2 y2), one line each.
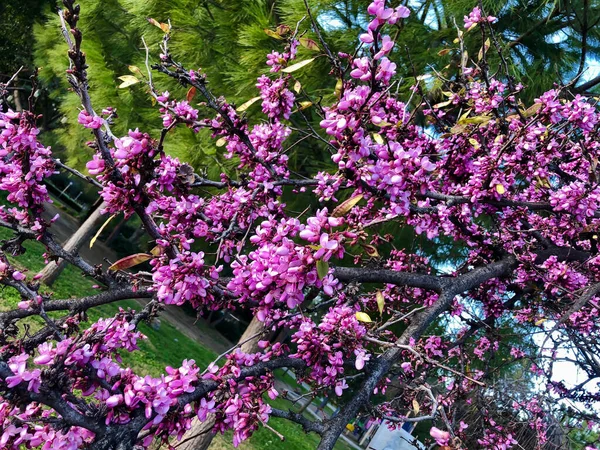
177 317 265 450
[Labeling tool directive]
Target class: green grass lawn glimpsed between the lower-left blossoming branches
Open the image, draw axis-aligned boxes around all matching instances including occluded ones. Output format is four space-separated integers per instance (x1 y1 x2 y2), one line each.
0 228 349 450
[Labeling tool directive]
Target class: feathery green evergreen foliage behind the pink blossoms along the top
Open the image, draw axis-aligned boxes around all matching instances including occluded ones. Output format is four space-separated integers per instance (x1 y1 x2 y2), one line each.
30 0 600 173
